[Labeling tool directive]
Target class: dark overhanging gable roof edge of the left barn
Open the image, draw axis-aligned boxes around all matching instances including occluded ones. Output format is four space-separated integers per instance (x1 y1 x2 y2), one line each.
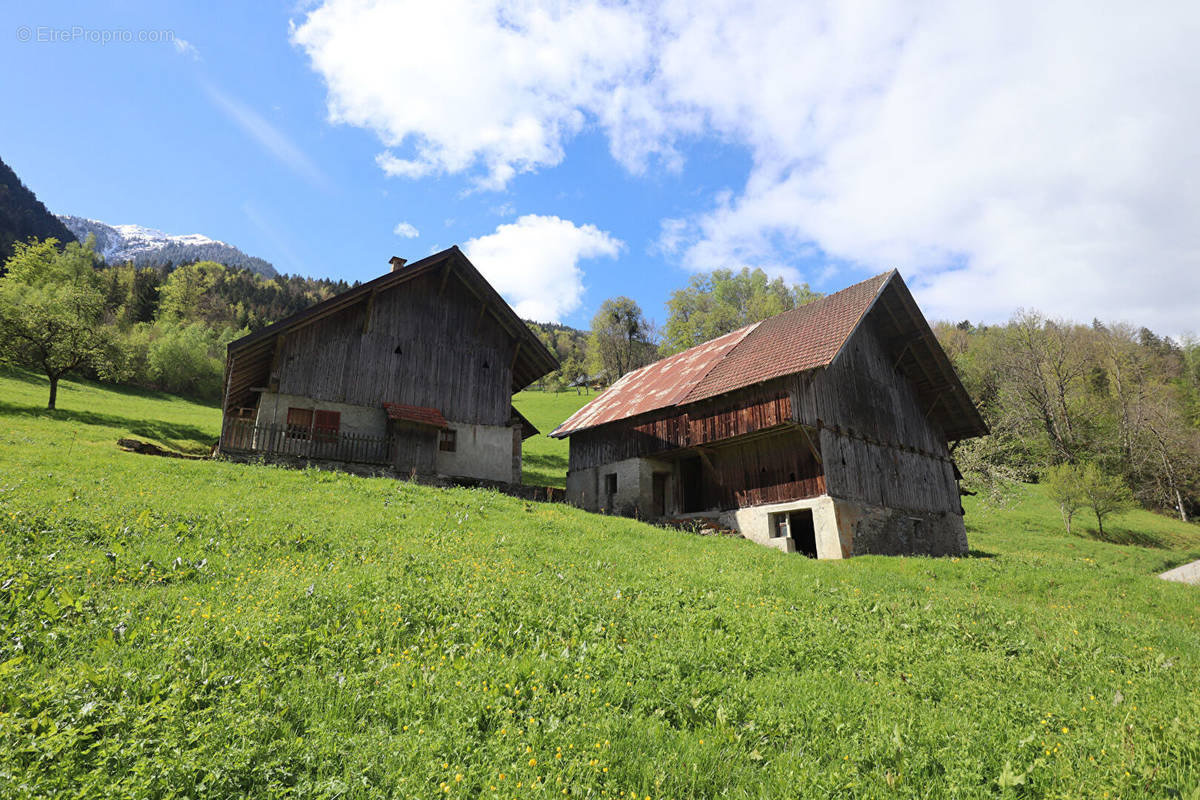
224 246 558 410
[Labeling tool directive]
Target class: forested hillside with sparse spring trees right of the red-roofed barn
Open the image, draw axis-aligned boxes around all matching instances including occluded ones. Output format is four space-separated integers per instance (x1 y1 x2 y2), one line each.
936 312 1200 519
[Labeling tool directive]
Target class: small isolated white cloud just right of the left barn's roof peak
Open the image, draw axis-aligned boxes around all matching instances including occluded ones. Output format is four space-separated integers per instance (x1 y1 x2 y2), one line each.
463 213 624 323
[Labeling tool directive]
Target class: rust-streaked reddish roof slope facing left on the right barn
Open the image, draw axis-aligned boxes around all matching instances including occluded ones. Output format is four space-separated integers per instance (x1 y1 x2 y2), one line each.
550 272 893 437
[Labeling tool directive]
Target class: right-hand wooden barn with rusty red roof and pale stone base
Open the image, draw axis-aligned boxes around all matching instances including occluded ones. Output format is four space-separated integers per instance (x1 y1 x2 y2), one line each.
550 271 986 558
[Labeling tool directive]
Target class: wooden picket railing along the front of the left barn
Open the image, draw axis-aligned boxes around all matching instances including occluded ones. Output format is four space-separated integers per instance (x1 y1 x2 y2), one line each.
221 420 391 464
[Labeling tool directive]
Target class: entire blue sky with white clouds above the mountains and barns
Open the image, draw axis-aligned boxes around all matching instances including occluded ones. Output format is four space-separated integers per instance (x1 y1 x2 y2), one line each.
0 0 1200 333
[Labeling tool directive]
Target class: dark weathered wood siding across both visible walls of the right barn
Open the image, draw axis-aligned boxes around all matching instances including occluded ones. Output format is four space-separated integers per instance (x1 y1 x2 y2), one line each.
570 320 960 512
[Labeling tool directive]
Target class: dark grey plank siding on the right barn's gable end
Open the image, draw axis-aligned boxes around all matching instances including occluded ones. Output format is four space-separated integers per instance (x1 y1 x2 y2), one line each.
802 324 960 512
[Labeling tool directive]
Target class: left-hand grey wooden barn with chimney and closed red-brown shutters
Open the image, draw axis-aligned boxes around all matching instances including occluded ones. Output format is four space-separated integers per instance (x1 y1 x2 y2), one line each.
220 247 558 483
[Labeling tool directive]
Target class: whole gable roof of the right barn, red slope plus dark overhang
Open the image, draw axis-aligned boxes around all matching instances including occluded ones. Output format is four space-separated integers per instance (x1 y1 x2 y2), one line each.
550 270 988 439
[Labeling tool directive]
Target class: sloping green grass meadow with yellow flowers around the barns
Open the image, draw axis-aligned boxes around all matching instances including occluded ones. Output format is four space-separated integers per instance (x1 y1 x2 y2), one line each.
0 377 1200 800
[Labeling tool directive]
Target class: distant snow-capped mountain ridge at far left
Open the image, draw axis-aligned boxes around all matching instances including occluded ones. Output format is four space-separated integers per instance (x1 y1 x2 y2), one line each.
58 213 276 277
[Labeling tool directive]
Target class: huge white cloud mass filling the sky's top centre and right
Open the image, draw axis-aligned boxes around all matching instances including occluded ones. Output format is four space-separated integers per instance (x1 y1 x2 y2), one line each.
293 0 1200 332
